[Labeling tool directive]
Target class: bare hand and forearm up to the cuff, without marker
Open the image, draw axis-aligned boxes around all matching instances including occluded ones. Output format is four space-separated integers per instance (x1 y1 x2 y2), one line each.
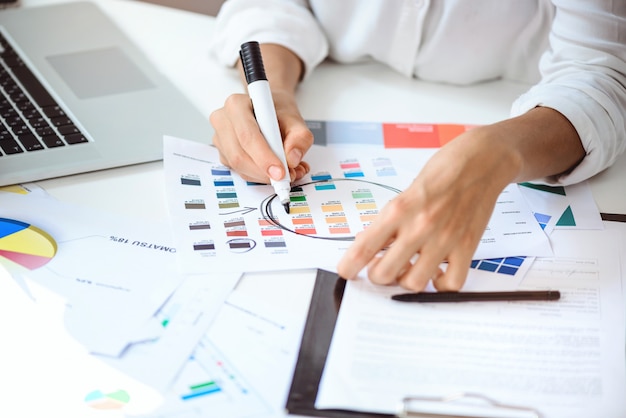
337 108 585 292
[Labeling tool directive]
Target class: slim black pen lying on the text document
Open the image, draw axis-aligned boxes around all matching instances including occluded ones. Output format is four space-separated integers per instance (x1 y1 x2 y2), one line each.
391 290 561 303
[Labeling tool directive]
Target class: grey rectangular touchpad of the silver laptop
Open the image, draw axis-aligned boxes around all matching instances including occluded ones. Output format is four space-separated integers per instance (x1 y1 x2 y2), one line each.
46 48 154 99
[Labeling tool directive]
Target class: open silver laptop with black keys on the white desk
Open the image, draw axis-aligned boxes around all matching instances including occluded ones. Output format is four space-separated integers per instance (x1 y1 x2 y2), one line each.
0 2 213 186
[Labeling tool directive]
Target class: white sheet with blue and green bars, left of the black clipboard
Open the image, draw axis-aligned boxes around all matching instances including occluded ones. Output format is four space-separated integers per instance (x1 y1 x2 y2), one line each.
141 270 315 418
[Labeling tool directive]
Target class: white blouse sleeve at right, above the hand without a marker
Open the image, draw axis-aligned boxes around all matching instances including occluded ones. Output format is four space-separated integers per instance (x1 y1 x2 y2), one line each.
511 0 626 184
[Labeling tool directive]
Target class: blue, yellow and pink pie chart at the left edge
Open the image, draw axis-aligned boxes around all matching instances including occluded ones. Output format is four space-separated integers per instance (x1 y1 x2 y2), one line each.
0 218 57 270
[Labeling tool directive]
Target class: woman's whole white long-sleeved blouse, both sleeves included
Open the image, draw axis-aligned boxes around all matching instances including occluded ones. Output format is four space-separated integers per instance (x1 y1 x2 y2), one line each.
211 0 626 184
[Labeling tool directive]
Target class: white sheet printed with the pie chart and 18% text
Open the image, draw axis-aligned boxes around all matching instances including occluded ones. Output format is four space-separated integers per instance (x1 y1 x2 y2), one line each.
0 193 181 357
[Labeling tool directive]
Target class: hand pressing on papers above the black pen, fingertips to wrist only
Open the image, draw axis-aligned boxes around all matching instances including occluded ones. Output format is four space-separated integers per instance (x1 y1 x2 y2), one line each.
338 131 516 292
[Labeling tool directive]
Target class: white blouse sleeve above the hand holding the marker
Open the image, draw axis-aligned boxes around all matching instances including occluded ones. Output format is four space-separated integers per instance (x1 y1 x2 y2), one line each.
210 0 328 77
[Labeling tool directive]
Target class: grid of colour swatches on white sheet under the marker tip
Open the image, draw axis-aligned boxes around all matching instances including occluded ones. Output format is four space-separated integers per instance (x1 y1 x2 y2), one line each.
166 140 410 273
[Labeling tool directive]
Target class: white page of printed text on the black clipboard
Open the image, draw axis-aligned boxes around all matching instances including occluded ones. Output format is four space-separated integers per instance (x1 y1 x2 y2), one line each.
316 229 626 418
